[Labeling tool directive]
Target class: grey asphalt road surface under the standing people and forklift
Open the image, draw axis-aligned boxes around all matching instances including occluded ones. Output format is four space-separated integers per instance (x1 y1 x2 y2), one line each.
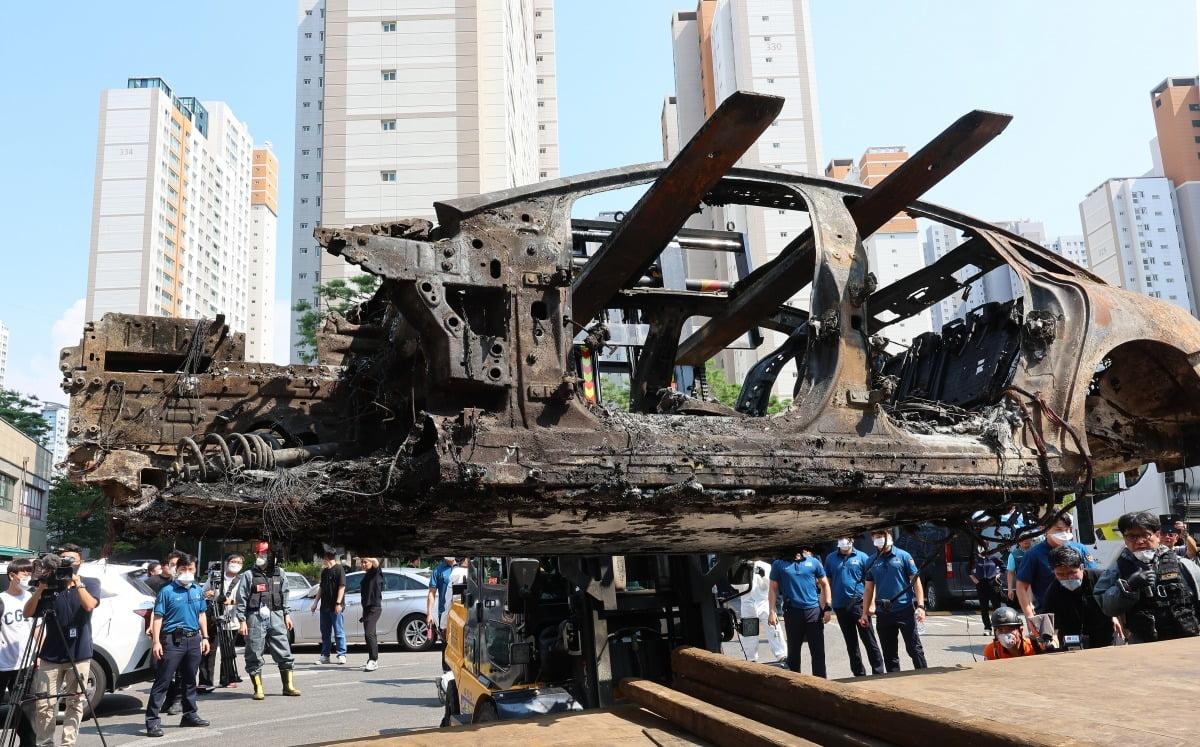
46 611 990 747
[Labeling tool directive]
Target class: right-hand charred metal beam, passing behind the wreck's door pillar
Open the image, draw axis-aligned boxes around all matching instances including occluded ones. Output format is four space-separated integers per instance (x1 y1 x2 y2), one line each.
679 109 1013 365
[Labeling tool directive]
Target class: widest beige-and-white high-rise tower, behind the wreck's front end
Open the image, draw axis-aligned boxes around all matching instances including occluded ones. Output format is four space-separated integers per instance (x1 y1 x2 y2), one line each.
292 0 558 357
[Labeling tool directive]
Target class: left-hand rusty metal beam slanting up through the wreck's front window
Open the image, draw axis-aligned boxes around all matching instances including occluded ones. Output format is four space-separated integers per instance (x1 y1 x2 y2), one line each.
571 91 784 324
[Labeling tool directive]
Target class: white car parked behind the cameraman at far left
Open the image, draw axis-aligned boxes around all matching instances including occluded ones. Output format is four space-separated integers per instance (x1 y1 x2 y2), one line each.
0 561 155 717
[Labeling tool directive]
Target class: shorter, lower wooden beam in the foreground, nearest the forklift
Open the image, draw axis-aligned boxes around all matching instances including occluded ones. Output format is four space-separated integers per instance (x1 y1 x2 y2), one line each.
619 679 816 747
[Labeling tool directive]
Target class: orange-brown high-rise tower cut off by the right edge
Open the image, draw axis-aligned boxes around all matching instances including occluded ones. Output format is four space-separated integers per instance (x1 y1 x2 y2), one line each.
1150 77 1200 307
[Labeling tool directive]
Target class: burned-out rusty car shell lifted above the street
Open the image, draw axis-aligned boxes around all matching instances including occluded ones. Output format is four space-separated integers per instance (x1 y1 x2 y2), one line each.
61 94 1200 555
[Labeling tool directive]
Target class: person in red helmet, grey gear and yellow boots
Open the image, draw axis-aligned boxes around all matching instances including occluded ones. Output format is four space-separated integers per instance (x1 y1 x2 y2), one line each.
238 542 300 700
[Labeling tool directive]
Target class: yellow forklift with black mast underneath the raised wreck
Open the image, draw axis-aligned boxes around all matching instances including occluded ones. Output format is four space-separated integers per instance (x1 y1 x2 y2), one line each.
438 555 758 727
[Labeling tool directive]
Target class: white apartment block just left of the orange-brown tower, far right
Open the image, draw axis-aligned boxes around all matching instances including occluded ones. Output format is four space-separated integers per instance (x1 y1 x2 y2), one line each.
1079 177 1195 313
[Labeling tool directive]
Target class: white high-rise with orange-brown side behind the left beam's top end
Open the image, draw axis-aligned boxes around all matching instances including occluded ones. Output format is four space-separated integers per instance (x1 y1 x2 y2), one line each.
662 0 822 396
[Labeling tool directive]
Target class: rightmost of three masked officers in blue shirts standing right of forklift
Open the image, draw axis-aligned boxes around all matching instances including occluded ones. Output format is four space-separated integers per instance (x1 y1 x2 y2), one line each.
859 530 928 671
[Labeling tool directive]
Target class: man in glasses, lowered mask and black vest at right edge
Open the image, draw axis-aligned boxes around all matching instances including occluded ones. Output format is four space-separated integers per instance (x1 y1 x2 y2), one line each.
1094 510 1200 644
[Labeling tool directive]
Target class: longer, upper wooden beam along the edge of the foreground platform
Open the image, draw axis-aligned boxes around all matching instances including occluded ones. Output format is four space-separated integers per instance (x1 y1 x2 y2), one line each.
671 647 1080 747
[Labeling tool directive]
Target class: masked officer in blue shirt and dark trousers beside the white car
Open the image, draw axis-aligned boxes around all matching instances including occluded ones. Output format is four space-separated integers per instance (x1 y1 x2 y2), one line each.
146 555 209 736
